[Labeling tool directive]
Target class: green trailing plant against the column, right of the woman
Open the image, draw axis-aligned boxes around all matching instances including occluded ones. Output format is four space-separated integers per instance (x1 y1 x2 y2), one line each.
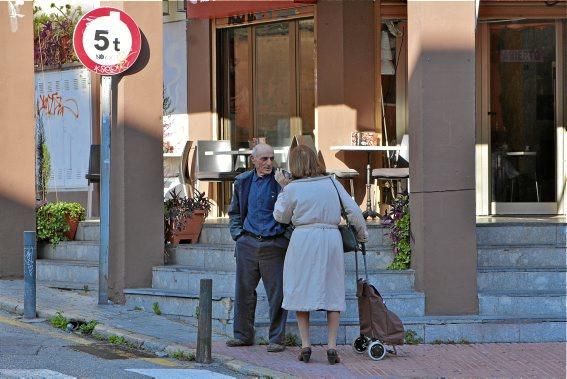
382 192 411 270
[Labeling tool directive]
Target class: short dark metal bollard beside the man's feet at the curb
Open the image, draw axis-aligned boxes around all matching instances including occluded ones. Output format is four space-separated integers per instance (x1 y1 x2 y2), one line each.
196 279 213 363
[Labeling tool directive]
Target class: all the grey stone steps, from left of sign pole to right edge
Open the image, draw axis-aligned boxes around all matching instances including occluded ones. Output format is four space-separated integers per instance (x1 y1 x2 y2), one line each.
37 219 567 344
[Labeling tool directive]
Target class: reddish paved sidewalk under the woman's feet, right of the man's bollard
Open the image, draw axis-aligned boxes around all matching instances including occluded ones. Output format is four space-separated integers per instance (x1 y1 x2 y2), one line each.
215 343 566 378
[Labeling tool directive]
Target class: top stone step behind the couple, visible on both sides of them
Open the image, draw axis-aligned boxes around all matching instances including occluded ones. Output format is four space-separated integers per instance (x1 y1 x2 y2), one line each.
199 218 391 248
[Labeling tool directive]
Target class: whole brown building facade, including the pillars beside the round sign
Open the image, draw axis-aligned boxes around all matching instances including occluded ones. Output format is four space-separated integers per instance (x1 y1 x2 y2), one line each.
0 0 567 315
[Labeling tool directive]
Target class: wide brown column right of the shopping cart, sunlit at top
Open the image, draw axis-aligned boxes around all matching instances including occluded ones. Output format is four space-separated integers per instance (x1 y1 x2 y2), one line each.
407 0 478 315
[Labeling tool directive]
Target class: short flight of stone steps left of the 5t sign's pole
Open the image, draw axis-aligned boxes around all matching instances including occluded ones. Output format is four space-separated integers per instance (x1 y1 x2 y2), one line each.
37 221 100 290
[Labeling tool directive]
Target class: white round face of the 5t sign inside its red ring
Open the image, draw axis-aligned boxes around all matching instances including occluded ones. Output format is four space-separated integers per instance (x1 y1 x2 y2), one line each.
83 12 132 66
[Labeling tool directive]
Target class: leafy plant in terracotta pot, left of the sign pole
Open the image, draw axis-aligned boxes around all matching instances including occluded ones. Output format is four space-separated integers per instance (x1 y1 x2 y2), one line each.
36 201 85 244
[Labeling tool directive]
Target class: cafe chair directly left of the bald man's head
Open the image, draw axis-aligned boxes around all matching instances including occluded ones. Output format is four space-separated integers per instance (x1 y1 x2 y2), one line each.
195 140 240 182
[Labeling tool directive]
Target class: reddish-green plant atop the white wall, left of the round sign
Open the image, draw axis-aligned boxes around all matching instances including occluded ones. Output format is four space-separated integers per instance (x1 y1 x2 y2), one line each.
33 4 83 70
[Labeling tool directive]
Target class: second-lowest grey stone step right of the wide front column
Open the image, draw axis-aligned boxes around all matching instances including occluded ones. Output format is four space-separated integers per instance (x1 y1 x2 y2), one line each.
478 289 567 317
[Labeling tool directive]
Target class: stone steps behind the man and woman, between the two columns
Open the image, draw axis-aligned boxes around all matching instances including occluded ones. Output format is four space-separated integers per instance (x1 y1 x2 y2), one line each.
125 222 425 343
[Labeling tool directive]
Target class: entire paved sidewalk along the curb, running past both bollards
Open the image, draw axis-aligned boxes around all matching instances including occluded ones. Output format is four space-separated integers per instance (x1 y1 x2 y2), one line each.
0 280 566 378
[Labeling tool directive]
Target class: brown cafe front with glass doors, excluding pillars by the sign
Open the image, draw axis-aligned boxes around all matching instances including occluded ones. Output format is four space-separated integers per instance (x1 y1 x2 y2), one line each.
187 0 567 314
